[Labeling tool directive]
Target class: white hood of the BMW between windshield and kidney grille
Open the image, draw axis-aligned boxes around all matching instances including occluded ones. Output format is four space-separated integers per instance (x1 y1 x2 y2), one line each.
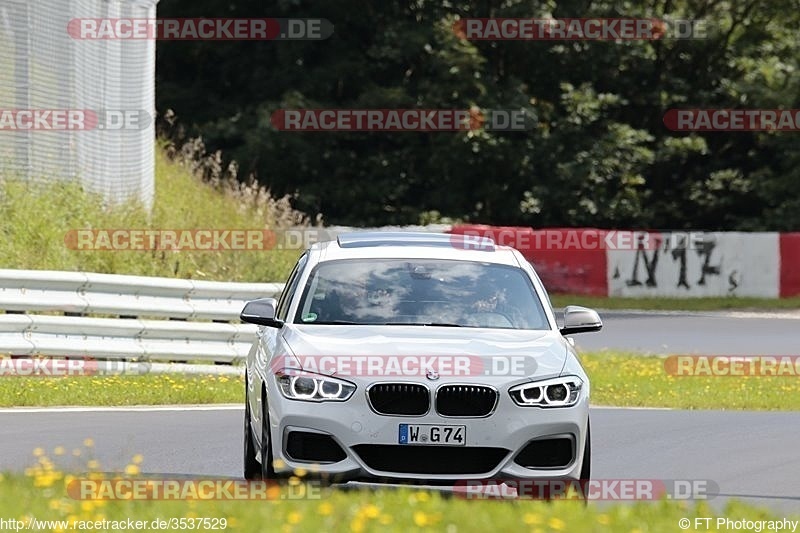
282 324 568 383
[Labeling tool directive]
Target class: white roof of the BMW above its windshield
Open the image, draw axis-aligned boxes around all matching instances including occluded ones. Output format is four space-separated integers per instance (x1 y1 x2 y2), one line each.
310 231 520 266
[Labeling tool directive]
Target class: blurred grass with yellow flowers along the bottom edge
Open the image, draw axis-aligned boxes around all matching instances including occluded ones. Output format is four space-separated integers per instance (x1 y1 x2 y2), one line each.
0 449 783 533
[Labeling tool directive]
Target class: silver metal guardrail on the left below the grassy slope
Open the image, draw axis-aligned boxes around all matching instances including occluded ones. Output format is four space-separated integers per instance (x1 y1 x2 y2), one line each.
0 270 283 363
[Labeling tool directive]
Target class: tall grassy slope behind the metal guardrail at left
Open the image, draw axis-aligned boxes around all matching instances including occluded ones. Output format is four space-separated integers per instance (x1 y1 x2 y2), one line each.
0 143 307 282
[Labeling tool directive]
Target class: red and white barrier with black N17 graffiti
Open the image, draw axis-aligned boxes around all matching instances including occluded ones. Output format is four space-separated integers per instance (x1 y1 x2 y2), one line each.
450 224 800 298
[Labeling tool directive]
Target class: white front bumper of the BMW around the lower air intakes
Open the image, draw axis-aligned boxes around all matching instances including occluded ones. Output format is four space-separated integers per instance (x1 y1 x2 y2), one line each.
268 381 589 483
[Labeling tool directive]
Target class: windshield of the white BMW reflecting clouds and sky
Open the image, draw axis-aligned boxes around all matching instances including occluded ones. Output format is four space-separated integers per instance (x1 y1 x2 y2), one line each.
295 259 549 329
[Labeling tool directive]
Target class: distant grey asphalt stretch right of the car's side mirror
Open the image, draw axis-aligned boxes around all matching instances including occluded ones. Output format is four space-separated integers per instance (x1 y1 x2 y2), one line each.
574 311 800 355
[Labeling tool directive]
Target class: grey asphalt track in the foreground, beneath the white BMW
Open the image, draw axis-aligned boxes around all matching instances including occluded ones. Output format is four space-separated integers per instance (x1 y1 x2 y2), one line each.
0 406 800 514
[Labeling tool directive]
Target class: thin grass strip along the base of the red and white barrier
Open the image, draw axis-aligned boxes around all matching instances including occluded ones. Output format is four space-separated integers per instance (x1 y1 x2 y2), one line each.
551 294 800 311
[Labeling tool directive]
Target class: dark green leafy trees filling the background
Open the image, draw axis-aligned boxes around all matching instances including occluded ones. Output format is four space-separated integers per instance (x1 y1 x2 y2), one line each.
158 0 800 230
